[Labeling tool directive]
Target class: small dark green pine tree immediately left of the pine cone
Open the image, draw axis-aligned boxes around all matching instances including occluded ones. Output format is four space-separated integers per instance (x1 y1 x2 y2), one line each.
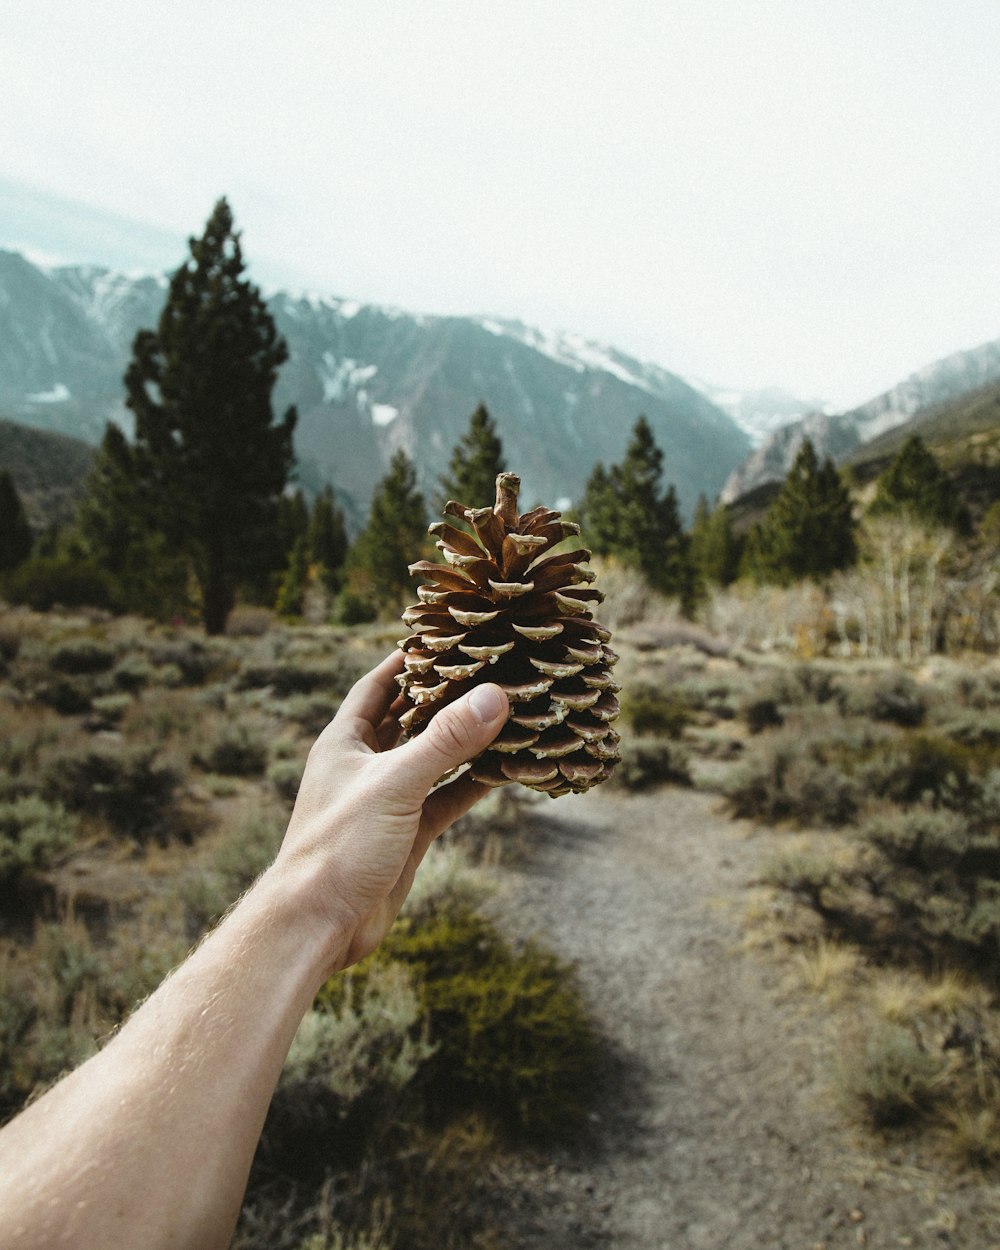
348 450 428 609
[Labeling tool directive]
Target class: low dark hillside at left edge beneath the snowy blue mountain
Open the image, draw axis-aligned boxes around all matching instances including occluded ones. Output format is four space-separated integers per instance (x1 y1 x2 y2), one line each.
0 420 94 530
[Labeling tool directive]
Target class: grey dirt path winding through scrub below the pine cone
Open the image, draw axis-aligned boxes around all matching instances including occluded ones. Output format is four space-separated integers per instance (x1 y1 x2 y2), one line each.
498 789 1000 1250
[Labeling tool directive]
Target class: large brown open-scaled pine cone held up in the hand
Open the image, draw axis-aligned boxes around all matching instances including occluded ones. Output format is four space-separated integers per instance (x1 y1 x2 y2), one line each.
398 473 619 798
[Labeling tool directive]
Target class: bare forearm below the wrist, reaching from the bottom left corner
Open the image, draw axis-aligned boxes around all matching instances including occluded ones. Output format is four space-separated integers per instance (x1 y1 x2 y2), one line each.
0 870 338 1250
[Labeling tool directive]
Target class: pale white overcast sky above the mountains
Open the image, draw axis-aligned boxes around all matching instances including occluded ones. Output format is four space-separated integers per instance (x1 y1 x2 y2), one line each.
0 0 1000 405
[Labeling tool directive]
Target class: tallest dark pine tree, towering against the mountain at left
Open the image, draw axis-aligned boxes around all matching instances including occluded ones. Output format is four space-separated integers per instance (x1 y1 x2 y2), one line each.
125 199 295 634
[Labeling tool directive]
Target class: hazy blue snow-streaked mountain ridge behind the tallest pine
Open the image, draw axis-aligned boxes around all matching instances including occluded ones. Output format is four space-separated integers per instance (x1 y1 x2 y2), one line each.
0 251 750 519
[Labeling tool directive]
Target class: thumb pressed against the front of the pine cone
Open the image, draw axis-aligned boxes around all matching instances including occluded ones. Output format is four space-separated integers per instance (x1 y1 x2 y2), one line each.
384 683 508 803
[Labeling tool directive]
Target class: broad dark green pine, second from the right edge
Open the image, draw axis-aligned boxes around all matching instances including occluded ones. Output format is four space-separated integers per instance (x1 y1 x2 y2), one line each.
741 439 858 585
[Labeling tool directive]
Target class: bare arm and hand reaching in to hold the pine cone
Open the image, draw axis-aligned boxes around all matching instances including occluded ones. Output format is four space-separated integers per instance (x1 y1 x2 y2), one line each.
0 654 508 1250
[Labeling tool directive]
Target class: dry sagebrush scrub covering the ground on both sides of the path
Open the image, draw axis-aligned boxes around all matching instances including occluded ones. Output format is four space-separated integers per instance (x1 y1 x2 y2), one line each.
0 570 1000 1250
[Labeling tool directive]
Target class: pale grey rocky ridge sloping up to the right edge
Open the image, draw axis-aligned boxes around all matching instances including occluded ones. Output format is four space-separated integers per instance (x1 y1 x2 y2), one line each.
721 339 1000 503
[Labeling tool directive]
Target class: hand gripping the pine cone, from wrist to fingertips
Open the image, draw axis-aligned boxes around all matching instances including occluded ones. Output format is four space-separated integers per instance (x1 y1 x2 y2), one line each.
275 653 508 973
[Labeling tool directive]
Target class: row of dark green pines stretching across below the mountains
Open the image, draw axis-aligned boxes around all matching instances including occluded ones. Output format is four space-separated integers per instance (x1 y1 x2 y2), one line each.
0 200 1000 633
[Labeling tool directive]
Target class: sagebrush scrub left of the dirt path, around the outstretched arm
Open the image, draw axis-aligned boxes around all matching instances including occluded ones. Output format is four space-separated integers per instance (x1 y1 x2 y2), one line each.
0 611 598 1250
